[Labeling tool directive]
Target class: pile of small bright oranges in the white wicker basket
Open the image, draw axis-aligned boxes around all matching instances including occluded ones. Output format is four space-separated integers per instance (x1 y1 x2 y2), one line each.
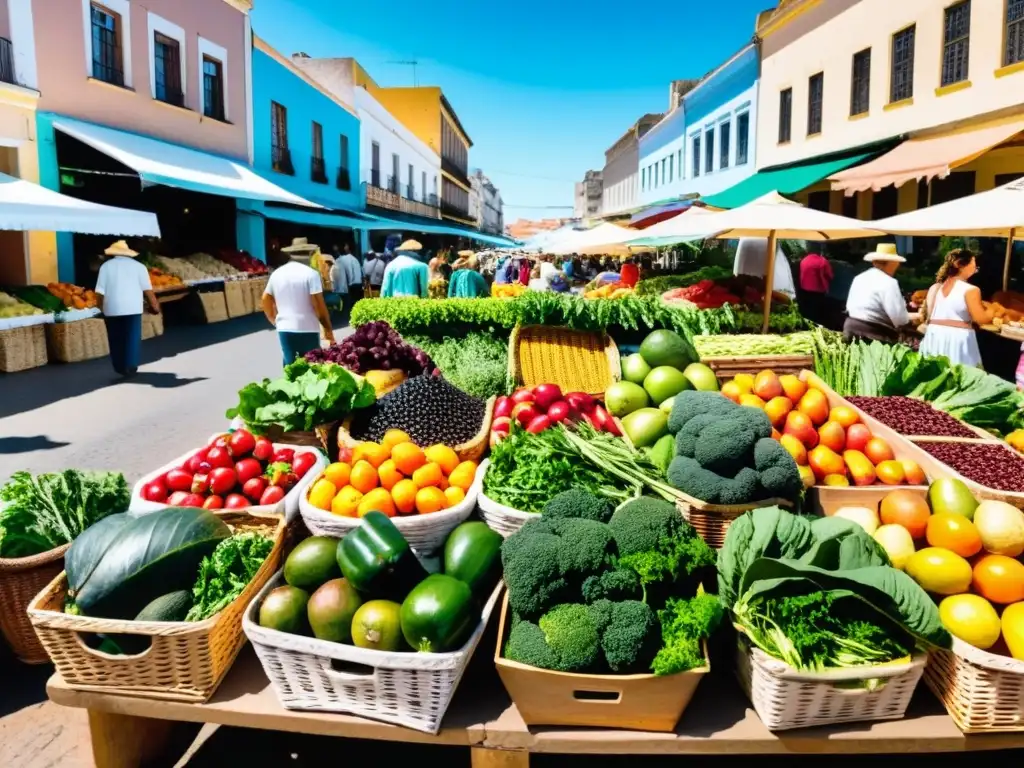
308 429 476 517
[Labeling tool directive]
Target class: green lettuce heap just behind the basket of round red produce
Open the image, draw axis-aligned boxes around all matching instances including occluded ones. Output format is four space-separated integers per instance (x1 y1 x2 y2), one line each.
227 359 376 434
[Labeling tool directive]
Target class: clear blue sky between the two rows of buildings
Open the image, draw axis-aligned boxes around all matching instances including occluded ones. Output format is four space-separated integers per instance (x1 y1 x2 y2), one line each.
253 0 773 221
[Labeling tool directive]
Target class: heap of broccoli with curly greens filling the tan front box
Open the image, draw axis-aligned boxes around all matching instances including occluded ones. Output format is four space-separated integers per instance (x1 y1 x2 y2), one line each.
501 490 722 676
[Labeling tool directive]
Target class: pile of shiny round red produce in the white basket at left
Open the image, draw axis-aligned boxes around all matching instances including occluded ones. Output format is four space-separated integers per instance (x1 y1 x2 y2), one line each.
142 429 316 509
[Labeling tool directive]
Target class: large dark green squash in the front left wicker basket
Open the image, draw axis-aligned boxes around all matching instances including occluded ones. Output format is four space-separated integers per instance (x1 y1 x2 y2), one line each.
67 507 231 618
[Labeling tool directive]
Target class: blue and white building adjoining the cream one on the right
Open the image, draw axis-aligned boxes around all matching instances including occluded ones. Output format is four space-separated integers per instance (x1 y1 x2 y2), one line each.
639 43 761 205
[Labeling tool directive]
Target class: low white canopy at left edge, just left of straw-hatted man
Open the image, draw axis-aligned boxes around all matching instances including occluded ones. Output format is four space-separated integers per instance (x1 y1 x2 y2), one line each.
0 173 160 238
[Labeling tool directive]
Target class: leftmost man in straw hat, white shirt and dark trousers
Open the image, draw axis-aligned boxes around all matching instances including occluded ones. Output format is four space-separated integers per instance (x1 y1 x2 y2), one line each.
96 240 160 379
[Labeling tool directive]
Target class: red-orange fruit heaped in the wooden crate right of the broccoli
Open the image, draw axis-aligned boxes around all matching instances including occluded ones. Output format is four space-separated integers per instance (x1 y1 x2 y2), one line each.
722 371 926 489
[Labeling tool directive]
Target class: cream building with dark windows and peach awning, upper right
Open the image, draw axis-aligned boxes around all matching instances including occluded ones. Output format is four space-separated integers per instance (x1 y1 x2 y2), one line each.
757 0 1024 218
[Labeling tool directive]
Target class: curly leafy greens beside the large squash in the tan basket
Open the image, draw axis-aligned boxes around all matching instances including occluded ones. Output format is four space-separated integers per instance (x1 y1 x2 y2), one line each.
185 531 273 622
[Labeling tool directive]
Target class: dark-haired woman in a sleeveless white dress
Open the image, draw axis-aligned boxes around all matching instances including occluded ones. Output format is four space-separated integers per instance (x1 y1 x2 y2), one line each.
921 249 992 368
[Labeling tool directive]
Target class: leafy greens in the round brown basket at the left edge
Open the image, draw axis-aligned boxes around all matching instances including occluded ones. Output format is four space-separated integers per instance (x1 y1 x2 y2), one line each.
0 469 131 557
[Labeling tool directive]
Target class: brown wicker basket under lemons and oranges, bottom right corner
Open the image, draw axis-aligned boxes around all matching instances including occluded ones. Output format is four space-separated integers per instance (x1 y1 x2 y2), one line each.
925 637 1024 733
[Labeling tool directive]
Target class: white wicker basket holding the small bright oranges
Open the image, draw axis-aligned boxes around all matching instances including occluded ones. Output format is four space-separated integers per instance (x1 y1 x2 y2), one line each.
299 468 483 555
